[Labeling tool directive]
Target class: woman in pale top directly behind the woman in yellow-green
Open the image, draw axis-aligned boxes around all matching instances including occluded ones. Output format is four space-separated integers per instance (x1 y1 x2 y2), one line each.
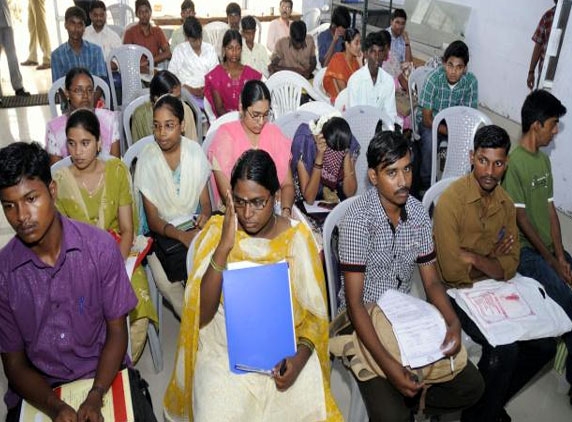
46 67 120 164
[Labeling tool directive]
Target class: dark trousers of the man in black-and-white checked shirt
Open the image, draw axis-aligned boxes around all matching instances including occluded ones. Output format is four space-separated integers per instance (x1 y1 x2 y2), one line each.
358 362 483 422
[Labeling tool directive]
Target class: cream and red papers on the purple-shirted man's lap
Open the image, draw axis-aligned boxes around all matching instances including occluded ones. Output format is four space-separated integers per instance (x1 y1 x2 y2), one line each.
20 369 135 422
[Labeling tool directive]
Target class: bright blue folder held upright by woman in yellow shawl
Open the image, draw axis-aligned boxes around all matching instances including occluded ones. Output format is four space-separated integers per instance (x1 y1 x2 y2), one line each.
222 262 296 374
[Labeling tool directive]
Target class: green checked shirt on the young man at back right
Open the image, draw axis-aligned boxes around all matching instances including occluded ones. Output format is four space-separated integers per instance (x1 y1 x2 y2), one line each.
417 66 479 122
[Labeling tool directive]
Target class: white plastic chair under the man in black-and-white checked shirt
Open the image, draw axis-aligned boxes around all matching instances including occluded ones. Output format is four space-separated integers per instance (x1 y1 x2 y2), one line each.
322 196 367 421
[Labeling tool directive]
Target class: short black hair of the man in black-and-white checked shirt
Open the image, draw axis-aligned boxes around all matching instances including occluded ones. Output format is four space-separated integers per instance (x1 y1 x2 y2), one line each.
367 130 409 169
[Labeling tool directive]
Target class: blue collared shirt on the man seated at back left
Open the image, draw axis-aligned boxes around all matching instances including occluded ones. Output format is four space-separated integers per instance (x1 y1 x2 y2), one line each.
51 40 108 82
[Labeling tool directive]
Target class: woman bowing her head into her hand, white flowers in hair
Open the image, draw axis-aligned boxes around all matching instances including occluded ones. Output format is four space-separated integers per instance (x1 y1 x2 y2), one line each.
291 113 360 204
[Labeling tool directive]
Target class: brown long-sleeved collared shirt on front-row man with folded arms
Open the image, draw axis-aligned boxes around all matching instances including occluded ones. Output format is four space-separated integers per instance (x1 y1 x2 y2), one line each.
433 173 520 287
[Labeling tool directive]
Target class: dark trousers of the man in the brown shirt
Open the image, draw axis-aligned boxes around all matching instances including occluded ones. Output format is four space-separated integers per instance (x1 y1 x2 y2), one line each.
451 300 556 422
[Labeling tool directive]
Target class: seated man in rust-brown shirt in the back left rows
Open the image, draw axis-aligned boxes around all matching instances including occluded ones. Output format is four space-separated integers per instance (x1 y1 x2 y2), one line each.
123 0 171 73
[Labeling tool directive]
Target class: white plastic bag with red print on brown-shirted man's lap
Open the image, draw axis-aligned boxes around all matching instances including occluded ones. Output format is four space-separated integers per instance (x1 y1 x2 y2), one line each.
447 275 572 346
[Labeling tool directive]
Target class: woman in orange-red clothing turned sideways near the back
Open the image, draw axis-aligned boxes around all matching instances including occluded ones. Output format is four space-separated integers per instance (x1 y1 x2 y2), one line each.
322 28 363 103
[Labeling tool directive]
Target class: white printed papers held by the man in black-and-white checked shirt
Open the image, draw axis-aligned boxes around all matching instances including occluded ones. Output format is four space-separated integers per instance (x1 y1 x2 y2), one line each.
377 290 447 368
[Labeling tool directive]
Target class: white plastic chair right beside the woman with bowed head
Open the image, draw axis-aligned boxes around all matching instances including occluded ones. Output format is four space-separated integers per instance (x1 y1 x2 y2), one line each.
342 106 379 194
